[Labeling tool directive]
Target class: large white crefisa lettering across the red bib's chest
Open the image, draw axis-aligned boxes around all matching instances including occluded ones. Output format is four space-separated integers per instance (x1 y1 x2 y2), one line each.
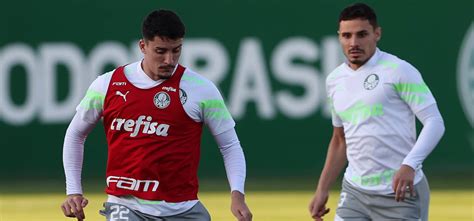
110 115 170 137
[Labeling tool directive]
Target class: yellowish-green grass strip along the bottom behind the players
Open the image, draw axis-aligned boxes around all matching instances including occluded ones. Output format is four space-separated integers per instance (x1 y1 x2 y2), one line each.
0 190 474 221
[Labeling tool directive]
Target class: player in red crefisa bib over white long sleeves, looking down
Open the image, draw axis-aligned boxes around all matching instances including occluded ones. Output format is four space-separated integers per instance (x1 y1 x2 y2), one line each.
61 10 252 221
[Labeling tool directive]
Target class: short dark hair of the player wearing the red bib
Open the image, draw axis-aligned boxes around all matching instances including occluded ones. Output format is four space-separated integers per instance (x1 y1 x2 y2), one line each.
142 9 186 40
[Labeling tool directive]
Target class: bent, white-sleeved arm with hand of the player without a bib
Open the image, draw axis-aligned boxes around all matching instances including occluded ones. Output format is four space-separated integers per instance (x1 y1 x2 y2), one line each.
392 64 445 201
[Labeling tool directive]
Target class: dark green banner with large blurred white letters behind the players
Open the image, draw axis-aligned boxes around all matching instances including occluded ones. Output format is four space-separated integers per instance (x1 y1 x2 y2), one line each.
0 0 474 179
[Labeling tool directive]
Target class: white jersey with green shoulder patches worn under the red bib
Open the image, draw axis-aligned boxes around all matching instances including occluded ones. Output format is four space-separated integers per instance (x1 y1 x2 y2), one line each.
76 62 241 216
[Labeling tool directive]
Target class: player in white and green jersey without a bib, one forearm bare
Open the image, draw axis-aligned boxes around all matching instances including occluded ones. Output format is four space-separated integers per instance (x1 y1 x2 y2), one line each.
309 3 445 220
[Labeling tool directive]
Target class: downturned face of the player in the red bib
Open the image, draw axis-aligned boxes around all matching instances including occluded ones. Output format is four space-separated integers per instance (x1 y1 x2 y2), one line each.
139 36 183 80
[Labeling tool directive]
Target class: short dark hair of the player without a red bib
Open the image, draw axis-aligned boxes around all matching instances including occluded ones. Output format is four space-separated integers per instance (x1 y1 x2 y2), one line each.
339 3 379 28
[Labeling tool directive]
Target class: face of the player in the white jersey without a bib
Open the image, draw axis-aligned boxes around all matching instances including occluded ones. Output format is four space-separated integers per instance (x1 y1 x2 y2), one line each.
338 19 381 70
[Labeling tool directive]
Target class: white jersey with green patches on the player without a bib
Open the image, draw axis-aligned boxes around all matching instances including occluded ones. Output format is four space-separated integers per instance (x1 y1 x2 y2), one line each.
326 48 436 193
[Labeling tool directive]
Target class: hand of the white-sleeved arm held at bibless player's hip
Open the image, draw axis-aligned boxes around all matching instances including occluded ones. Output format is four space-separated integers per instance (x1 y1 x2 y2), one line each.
392 165 416 202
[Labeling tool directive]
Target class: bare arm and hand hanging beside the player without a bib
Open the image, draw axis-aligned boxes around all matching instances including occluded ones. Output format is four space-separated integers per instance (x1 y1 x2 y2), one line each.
309 126 347 220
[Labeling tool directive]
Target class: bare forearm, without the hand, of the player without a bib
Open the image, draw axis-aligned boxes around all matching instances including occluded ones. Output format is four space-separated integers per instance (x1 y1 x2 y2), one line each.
318 133 347 191
